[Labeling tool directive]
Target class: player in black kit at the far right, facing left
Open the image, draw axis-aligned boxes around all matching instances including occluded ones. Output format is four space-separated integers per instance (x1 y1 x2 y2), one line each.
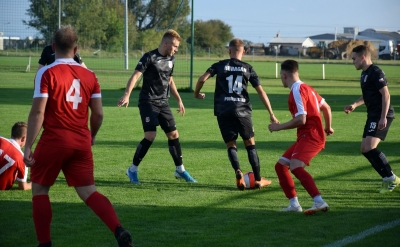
344 45 400 193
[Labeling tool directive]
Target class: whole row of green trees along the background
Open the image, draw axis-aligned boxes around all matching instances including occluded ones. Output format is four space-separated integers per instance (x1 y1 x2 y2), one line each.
23 0 233 51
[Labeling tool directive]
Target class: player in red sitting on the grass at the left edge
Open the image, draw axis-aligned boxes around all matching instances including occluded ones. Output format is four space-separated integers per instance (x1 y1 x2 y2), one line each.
0 122 31 190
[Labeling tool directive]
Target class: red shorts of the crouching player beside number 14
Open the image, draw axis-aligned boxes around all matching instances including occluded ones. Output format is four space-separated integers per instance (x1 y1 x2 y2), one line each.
282 134 325 166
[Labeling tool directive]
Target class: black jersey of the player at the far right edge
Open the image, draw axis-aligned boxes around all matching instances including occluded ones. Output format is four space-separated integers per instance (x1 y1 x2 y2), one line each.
360 64 394 118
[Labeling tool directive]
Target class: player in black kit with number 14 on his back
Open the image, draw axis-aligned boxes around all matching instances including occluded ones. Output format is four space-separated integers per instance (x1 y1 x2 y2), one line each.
194 39 278 190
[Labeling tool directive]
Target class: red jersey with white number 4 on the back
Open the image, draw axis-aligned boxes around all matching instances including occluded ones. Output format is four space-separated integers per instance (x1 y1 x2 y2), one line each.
33 58 101 150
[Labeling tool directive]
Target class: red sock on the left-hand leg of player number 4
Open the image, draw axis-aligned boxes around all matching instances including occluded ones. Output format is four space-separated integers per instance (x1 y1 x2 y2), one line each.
32 195 53 244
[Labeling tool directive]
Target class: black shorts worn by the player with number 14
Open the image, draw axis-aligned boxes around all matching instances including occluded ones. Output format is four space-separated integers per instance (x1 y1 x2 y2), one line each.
217 116 254 143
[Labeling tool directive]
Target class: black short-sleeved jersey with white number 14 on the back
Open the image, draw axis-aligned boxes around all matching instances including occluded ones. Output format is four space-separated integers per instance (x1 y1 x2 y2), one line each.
207 58 260 117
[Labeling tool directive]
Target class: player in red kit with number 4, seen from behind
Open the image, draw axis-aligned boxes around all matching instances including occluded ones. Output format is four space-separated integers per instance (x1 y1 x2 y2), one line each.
24 25 133 247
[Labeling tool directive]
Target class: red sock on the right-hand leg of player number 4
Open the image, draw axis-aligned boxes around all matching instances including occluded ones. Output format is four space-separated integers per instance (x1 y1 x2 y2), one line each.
85 191 120 233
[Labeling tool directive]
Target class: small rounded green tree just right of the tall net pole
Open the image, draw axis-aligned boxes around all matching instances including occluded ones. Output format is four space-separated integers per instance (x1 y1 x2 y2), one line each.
188 20 233 48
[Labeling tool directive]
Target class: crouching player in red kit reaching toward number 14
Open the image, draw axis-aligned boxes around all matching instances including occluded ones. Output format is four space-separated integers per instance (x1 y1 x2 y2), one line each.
268 60 334 215
